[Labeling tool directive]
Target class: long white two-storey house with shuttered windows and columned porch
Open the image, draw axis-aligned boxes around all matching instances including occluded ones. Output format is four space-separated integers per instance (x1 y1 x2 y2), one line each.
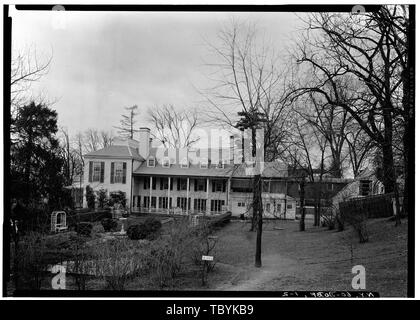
83 128 296 219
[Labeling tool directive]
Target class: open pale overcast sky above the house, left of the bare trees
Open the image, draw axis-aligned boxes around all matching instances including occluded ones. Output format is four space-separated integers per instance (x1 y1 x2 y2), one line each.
11 6 298 142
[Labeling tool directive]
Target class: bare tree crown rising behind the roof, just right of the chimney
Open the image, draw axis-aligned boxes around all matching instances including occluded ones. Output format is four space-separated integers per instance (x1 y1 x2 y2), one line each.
148 105 200 148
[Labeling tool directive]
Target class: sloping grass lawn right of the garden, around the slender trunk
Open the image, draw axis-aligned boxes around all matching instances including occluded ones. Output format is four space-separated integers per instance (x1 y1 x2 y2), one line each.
205 219 407 296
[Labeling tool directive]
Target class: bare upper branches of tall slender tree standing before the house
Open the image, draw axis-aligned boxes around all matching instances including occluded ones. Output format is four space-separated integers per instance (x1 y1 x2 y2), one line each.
203 21 289 161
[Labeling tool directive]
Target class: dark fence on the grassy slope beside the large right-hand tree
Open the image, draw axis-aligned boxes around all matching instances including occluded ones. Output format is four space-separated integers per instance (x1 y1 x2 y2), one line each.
339 193 394 218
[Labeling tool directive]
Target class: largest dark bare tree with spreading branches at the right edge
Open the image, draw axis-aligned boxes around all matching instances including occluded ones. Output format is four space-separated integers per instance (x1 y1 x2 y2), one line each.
288 7 402 224
